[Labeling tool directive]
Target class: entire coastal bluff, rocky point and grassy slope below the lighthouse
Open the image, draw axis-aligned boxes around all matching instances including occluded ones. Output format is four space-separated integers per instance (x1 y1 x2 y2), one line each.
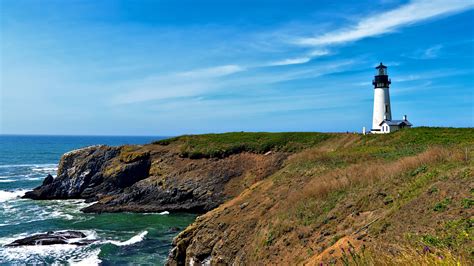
25 127 474 265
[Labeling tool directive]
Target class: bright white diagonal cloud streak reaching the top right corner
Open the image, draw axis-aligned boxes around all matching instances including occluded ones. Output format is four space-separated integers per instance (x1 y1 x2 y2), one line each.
294 0 474 46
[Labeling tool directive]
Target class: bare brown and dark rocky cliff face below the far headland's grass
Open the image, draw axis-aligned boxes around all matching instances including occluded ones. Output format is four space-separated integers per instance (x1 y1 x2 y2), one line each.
25 139 288 213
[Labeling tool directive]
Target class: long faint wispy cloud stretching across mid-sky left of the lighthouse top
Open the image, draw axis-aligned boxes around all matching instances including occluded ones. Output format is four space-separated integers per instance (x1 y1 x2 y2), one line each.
109 60 354 105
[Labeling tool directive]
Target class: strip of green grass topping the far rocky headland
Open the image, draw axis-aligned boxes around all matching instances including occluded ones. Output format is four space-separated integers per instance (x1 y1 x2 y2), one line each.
154 132 334 158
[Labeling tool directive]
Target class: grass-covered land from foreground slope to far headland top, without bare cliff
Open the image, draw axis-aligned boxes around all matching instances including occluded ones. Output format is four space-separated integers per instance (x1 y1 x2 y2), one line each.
170 127 474 265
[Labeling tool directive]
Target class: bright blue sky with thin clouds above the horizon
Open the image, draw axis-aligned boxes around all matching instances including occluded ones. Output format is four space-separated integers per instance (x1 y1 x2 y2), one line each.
0 0 474 135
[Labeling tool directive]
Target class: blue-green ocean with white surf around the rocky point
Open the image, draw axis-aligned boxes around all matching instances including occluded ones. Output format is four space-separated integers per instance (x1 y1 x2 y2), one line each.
0 135 196 265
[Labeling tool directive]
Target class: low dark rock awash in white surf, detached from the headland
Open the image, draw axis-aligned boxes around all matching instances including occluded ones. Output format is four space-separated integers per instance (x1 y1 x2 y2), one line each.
5 231 95 247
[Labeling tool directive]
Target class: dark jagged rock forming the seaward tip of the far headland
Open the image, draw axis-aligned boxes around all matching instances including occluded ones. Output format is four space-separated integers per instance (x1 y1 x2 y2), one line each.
24 145 150 201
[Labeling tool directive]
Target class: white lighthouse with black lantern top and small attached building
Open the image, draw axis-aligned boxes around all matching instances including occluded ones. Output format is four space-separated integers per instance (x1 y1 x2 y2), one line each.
371 63 412 133
